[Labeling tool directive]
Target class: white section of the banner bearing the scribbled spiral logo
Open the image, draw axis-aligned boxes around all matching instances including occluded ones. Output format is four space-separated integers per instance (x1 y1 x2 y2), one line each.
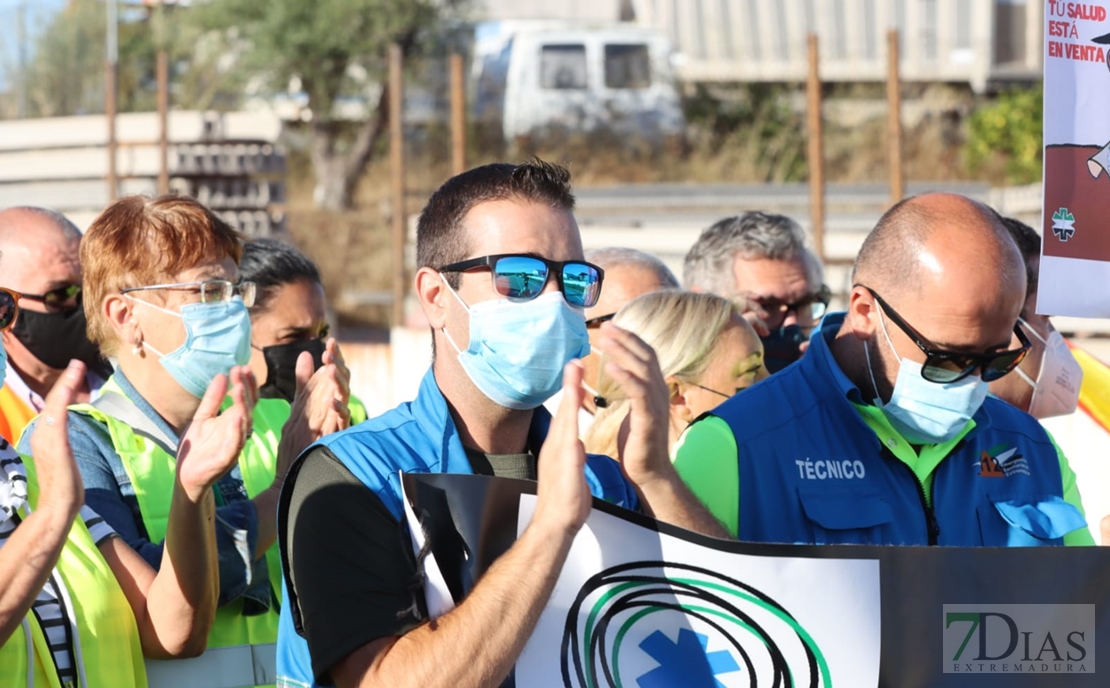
516 495 880 688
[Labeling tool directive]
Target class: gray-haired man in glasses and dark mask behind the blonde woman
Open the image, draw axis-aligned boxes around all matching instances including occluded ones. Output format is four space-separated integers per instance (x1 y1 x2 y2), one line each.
683 211 830 373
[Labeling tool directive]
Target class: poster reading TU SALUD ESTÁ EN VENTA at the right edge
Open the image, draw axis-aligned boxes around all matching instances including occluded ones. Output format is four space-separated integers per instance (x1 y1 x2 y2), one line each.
1037 0 1110 317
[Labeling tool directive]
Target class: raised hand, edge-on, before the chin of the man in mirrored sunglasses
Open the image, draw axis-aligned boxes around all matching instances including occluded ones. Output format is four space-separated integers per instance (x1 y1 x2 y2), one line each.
533 361 593 535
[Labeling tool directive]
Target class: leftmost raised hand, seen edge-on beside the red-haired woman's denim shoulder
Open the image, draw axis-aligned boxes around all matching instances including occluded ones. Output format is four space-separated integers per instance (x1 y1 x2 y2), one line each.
31 361 84 518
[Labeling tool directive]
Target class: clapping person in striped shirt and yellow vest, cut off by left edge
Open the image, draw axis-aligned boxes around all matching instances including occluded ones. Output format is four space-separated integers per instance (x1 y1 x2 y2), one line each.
0 254 254 688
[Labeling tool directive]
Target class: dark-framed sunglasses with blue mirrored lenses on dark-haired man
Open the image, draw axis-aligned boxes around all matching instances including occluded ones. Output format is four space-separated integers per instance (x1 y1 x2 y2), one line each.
438 253 605 308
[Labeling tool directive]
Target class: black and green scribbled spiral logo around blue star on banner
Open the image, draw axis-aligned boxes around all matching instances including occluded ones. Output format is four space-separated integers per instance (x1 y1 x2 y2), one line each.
562 561 833 688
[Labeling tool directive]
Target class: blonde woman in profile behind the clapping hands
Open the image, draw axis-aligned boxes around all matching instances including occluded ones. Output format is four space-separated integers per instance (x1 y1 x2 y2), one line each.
585 290 767 456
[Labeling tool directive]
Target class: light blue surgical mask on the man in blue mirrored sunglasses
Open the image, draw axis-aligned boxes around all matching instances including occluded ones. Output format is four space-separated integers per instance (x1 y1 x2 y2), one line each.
443 282 589 411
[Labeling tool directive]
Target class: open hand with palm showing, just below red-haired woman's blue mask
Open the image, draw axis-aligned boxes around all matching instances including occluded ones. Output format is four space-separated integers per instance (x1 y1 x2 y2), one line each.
178 366 256 502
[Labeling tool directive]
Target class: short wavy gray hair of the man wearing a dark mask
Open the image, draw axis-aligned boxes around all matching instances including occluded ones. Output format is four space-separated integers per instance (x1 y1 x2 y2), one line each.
683 211 825 296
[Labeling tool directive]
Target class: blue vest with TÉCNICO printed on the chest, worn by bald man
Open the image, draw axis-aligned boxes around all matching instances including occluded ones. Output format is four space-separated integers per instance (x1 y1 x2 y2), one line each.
713 316 1086 546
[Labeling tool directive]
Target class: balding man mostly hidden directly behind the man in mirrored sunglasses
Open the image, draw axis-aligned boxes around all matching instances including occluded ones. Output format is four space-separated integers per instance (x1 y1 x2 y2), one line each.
544 246 679 433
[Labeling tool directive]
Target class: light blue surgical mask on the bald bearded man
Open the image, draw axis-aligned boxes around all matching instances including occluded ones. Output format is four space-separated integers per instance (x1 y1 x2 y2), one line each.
864 304 987 444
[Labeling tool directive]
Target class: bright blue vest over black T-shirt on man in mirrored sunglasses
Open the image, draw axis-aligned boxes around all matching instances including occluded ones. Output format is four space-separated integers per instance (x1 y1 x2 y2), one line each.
278 371 639 688
